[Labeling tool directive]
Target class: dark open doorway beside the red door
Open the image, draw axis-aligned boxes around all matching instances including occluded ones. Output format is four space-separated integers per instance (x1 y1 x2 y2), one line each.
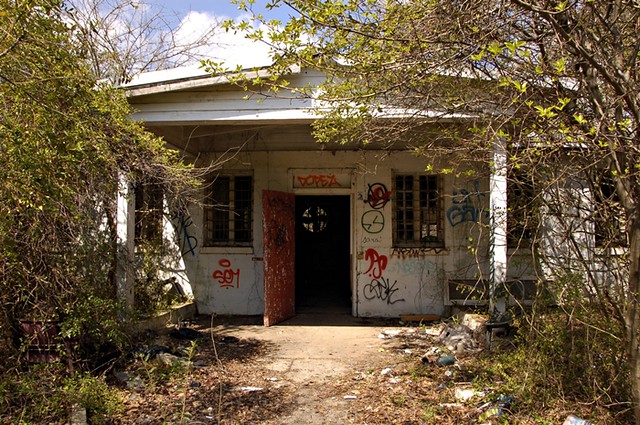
295 196 351 312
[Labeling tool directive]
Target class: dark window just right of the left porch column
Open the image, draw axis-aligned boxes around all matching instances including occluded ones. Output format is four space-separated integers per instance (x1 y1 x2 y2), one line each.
135 183 164 242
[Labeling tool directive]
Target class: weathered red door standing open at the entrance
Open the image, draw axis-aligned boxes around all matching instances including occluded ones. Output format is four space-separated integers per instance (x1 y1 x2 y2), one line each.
262 190 296 326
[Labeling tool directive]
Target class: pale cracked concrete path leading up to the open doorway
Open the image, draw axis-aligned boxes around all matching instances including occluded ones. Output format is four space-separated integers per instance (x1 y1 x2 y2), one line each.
208 312 400 425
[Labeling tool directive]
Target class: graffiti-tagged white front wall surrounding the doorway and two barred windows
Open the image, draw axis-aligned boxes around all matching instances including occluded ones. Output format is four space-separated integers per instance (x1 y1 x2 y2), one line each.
172 147 502 317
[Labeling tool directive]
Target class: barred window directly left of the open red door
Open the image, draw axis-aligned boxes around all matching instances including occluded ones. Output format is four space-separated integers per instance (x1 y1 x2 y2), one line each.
204 175 253 246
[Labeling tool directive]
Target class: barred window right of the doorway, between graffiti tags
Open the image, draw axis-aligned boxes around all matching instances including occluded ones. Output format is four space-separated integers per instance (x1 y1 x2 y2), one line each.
393 174 444 248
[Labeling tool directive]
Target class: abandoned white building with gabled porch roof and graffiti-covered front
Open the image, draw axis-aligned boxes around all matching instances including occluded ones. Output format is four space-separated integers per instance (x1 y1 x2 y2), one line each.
123 63 534 325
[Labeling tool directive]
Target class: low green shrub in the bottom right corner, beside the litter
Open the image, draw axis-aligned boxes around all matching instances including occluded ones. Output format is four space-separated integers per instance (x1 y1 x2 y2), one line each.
486 306 631 424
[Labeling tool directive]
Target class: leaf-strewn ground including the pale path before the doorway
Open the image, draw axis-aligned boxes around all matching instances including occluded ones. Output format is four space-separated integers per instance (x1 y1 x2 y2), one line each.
118 313 446 425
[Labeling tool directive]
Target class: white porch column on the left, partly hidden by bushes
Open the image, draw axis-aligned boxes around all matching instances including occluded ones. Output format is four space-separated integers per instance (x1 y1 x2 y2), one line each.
116 175 136 310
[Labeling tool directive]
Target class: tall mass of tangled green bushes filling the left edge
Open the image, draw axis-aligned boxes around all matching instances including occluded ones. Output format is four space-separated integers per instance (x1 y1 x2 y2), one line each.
0 0 196 422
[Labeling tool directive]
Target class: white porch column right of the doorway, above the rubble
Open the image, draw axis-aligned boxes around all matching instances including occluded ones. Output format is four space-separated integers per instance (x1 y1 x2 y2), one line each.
489 138 507 313
